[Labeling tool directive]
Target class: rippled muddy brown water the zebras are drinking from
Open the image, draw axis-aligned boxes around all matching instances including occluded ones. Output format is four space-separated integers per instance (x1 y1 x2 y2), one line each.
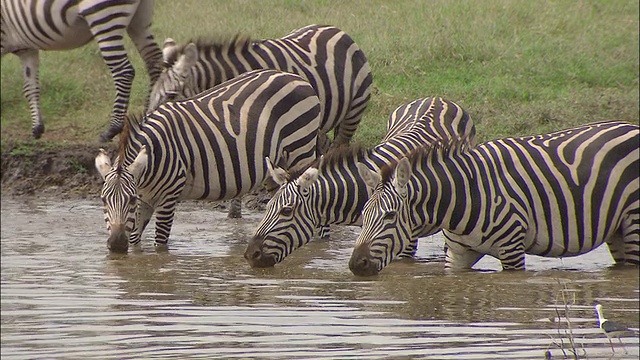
1 197 640 359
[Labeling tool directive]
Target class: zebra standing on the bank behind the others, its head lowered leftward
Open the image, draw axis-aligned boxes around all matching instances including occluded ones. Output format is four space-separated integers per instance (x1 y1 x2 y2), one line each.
148 25 372 147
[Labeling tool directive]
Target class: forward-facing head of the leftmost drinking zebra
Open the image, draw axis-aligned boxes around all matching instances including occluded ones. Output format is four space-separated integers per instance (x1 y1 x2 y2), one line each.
95 147 148 253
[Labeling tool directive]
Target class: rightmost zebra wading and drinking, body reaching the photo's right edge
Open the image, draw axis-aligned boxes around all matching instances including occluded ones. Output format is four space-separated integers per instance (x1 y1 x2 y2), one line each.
349 121 640 276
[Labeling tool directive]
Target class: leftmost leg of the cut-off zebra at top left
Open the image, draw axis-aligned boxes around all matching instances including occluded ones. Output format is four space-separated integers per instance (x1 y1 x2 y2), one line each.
15 49 44 139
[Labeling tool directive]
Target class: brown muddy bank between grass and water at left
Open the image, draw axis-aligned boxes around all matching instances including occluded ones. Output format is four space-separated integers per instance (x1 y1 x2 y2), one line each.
2 141 269 210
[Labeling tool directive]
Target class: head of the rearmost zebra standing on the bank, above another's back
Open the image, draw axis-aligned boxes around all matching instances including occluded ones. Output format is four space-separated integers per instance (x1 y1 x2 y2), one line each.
147 39 199 113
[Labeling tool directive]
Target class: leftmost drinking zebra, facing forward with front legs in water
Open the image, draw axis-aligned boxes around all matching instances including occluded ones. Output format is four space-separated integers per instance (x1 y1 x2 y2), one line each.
95 70 320 253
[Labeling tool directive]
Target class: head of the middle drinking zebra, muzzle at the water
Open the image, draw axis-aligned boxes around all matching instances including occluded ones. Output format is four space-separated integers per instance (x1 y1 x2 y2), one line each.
244 158 322 267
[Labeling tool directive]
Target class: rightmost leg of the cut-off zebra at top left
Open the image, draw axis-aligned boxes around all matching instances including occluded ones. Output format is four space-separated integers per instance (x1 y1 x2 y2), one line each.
127 1 163 109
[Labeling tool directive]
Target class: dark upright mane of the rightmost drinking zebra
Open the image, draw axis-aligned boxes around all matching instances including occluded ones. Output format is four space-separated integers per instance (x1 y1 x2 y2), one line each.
380 136 472 183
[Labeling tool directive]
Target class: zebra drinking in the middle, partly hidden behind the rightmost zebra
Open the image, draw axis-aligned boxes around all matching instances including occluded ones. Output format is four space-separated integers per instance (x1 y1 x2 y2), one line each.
244 98 475 267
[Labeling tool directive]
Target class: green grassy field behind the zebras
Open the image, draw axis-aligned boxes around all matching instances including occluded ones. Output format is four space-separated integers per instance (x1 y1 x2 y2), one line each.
2 0 640 147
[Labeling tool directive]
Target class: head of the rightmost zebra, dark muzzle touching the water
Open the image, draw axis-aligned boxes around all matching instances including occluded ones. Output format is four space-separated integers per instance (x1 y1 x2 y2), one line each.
349 158 411 276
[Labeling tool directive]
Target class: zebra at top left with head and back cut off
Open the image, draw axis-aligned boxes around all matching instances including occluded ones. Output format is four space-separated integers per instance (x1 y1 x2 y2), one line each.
0 0 162 142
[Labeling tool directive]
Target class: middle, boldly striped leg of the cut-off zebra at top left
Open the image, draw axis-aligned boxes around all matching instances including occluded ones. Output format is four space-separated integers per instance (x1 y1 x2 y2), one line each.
79 1 138 142
